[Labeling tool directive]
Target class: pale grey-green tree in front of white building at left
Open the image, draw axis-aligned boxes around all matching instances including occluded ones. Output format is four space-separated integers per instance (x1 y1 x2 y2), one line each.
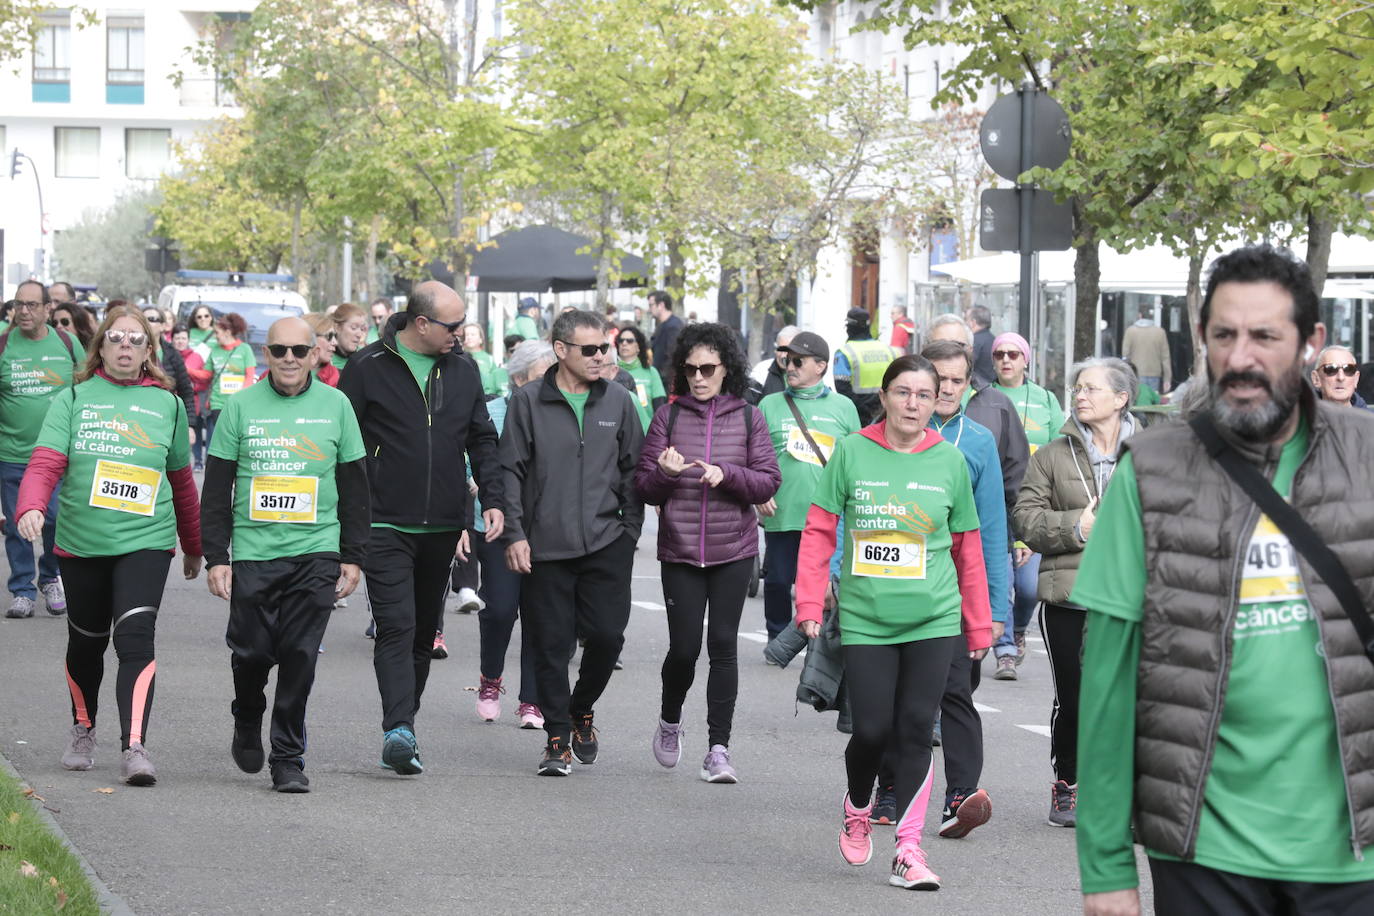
54 188 159 301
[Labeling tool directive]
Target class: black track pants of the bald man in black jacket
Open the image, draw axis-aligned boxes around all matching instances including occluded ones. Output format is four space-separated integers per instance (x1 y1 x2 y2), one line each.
363 527 459 731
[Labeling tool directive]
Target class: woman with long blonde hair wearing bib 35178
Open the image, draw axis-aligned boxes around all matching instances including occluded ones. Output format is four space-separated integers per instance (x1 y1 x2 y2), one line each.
18 305 201 786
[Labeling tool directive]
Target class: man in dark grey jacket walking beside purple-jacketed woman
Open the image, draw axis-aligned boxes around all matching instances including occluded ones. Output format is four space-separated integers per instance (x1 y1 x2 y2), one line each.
502 310 644 776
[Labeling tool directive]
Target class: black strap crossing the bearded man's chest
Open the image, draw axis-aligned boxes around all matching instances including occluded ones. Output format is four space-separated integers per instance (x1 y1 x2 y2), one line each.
1189 413 1374 661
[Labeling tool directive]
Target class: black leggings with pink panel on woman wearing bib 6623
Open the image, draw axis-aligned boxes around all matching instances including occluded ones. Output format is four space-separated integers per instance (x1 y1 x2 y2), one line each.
845 636 958 842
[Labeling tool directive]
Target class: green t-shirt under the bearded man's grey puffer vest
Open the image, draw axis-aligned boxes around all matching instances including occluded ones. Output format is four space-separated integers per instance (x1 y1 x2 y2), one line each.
1072 420 1374 882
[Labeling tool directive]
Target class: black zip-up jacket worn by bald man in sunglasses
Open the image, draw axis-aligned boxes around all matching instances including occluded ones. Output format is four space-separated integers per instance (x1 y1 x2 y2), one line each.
339 312 506 529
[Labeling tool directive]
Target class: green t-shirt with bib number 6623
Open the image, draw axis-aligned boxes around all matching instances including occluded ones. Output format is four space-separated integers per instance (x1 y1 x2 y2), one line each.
807 436 978 645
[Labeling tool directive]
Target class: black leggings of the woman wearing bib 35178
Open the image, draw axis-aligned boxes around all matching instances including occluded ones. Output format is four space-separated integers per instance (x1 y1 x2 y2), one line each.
58 551 172 750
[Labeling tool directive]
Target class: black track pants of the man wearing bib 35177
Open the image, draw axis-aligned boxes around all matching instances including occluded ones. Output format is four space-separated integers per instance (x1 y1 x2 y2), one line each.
225 556 339 762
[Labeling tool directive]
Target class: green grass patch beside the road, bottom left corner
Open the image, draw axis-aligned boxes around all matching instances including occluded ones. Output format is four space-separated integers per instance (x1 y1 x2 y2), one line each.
0 772 100 916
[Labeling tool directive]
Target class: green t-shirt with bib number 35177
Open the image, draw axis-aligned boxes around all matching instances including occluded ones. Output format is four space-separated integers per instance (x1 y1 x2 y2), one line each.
210 379 365 560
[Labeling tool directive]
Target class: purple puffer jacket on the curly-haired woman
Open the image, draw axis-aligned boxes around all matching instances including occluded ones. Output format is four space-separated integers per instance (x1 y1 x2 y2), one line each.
635 394 782 566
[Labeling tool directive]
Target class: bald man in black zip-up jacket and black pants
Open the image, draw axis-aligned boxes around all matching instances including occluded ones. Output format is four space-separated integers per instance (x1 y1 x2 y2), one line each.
339 280 506 775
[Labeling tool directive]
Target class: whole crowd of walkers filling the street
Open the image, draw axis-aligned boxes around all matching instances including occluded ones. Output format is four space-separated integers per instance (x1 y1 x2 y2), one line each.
0 246 1374 916
